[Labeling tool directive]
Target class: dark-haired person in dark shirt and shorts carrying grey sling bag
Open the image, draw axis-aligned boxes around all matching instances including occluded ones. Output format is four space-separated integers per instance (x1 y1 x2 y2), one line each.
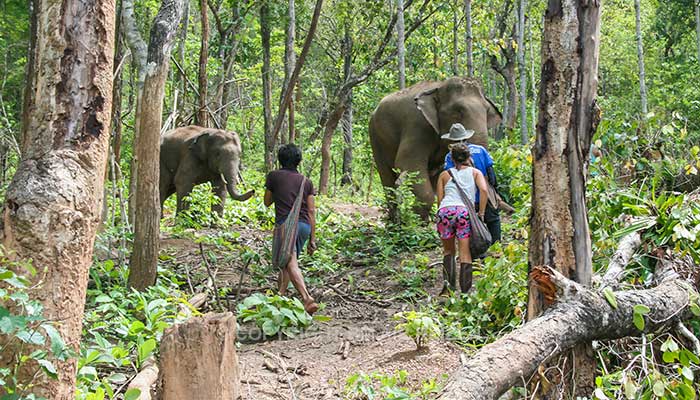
264 143 318 314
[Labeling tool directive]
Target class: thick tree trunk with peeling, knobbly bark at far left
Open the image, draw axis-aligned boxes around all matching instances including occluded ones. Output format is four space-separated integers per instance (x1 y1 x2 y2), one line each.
0 0 115 400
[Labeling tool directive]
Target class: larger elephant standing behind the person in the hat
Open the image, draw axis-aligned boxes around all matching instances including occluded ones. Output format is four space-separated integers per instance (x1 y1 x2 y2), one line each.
369 77 502 221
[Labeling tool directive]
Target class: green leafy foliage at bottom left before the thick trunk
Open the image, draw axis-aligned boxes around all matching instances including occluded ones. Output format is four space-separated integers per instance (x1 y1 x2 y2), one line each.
0 249 74 400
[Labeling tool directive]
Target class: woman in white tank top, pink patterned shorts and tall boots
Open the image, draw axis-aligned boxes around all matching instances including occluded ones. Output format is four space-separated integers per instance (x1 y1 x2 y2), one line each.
437 142 488 293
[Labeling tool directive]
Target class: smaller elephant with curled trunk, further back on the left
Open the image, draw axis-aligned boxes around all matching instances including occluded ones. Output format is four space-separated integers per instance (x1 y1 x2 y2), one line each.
159 125 255 215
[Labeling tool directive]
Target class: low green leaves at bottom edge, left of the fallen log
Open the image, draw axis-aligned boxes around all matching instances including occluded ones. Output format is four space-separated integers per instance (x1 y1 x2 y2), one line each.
343 370 444 400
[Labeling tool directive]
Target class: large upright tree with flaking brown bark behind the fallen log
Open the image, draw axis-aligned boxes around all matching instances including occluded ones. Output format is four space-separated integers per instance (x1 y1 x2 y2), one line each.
527 0 600 397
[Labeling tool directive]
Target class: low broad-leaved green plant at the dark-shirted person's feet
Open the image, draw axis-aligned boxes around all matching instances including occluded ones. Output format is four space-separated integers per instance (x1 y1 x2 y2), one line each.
238 293 326 337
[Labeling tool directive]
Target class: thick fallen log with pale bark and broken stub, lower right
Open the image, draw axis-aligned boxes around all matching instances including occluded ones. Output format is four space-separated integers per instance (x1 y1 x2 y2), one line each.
438 267 697 400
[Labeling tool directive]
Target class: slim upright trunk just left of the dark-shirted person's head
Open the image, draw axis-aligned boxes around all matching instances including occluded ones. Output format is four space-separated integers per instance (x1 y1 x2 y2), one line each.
260 2 276 172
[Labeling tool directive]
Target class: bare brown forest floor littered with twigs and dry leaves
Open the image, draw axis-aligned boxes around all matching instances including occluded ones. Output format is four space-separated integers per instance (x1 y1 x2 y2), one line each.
161 204 461 400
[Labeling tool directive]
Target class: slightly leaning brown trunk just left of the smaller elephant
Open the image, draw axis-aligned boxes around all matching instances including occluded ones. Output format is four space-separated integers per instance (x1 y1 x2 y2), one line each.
128 0 183 290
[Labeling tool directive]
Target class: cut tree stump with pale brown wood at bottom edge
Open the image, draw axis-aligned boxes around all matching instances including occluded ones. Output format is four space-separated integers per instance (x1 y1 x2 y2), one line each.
160 312 240 400
